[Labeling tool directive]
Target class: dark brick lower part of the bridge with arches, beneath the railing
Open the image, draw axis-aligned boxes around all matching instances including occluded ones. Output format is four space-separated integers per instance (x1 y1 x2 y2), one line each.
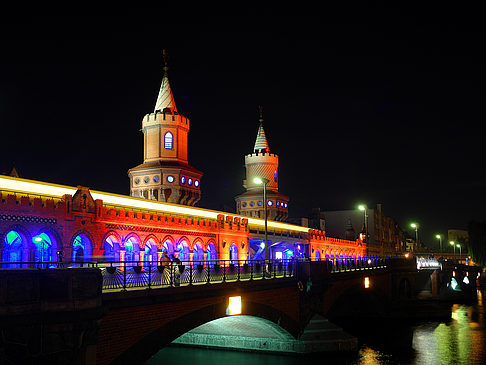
0 260 416 364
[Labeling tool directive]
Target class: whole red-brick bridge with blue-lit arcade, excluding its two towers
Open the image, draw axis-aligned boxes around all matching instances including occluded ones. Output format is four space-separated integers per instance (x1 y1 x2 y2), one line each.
0 176 416 364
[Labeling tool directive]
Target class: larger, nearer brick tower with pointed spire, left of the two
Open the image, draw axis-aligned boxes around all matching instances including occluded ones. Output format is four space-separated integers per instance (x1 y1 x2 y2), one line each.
128 50 203 205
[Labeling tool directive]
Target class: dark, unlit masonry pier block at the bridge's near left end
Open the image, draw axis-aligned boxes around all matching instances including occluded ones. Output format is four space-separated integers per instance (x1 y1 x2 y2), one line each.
0 268 103 365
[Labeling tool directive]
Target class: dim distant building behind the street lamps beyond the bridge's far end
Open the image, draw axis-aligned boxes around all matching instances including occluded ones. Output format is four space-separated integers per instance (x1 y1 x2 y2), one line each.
323 204 410 257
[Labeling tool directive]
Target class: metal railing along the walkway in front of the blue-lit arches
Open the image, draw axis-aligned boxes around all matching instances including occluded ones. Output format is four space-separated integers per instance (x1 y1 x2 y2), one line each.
0 260 295 291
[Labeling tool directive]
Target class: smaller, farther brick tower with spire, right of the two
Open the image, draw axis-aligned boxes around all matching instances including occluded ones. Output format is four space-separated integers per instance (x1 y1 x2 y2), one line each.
235 107 289 221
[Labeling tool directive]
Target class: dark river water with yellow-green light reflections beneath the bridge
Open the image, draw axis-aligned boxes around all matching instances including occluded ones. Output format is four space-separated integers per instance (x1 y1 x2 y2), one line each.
145 291 486 365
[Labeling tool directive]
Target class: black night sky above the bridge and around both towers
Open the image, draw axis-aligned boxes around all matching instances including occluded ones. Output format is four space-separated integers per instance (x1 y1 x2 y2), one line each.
0 7 486 247
